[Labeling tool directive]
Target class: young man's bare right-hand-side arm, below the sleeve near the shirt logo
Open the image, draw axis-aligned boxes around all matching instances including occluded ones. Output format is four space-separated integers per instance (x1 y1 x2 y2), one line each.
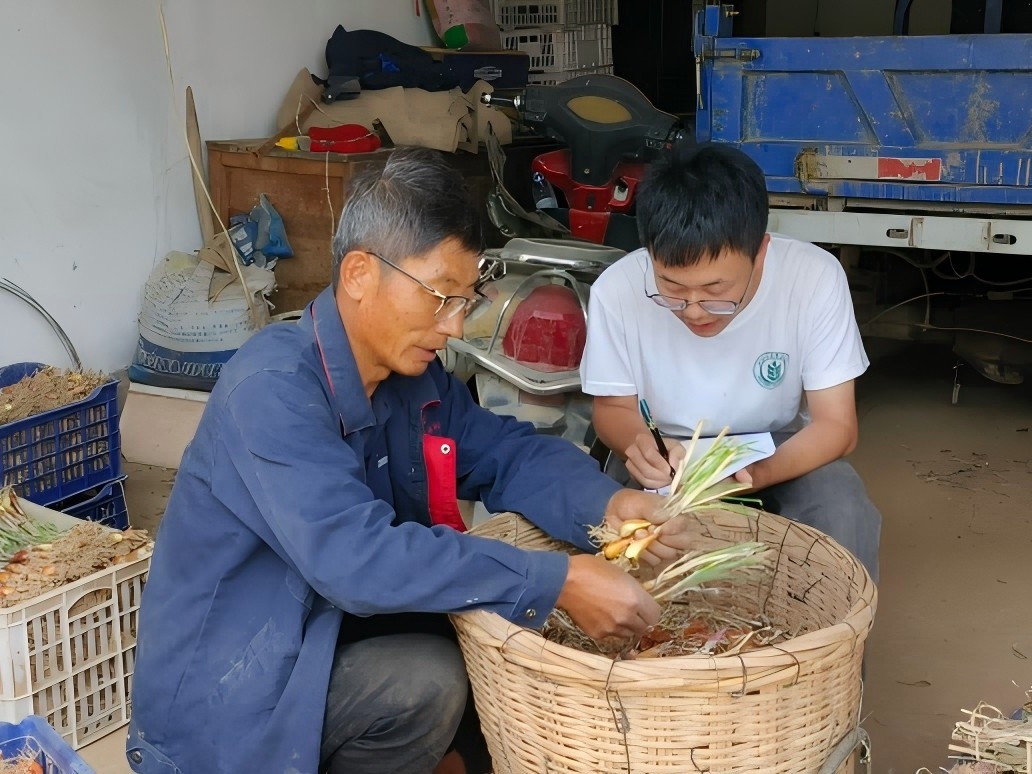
736 380 858 489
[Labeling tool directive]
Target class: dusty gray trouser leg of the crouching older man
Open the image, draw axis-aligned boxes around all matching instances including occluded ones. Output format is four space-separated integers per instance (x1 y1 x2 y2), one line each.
320 634 467 774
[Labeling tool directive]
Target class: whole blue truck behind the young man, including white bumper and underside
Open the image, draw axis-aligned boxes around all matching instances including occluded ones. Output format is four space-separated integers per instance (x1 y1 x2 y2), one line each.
694 0 1032 383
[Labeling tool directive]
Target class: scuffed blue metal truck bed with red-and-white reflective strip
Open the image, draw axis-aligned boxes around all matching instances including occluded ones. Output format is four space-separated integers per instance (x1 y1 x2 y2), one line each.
695 6 1032 209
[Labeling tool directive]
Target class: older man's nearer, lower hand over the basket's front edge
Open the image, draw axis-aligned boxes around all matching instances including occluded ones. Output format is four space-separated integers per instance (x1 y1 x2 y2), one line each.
555 554 659 640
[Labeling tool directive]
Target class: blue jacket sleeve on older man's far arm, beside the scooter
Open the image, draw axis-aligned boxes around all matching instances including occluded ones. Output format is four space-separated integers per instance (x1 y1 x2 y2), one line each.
431 364 621 552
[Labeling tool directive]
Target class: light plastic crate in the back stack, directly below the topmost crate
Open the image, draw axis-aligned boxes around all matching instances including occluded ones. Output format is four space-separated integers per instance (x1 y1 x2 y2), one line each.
502 24 613 72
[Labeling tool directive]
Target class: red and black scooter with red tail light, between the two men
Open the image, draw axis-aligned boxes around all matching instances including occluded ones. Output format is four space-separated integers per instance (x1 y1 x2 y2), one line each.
445 75 687 449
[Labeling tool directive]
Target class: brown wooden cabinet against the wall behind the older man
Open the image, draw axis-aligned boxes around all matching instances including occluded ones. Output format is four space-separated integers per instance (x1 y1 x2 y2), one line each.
207 140 497 313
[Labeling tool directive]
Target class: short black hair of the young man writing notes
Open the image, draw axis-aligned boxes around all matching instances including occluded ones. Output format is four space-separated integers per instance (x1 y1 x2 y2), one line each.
635 142 769 266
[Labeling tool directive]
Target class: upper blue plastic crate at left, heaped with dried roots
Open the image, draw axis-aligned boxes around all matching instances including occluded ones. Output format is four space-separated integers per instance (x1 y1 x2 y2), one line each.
0 363 122 506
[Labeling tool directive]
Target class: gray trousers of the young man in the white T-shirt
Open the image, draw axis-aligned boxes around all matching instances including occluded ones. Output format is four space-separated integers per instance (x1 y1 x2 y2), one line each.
606 432 881 583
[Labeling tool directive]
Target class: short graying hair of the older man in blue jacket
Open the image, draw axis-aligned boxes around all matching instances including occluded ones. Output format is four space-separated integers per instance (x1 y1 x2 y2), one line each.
333 148 484 288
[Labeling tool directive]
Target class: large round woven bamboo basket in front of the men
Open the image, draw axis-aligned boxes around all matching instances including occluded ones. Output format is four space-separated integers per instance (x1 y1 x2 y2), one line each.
452 511 876 774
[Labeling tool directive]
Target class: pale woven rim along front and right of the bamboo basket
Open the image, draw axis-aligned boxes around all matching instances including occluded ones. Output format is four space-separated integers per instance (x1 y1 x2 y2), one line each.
451 514 877 685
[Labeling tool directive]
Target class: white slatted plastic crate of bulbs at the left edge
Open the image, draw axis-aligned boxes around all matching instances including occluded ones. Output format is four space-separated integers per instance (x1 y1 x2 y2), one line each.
0 499 151 749
